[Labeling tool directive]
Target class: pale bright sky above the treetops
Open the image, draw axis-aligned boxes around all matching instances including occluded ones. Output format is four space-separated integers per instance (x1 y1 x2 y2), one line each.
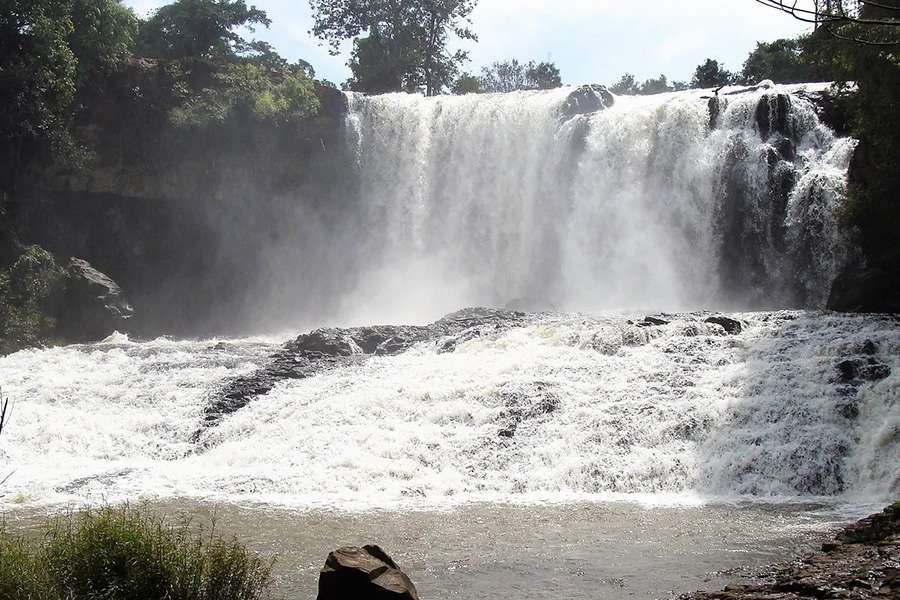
124 0 809 84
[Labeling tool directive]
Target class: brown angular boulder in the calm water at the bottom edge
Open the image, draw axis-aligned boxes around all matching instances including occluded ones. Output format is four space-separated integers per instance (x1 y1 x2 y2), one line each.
318 546 419 600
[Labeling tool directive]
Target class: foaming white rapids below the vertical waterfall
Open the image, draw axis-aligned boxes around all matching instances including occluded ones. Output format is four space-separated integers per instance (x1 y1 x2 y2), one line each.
0 313 900 509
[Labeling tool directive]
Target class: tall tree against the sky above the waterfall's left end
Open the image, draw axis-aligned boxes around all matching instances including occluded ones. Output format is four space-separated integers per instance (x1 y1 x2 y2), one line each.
310 0 477 95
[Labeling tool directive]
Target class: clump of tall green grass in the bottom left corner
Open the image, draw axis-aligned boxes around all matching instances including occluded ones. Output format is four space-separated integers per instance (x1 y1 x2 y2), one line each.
0 507 272 600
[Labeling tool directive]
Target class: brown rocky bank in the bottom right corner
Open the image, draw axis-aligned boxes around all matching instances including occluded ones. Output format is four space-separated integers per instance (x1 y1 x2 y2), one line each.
681 502 900 600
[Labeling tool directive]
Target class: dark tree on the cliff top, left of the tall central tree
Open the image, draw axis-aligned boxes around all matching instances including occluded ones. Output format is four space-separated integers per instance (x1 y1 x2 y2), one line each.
139 0 271 59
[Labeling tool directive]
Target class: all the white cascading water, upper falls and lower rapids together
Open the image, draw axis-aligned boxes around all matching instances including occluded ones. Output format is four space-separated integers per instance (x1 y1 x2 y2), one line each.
0 87 900 508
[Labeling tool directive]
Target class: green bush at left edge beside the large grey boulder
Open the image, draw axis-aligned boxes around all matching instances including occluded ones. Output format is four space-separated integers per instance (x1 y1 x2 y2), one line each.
0 246 66 354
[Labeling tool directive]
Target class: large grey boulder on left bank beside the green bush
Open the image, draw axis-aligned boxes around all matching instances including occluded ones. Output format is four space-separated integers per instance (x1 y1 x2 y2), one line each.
58 258 134 342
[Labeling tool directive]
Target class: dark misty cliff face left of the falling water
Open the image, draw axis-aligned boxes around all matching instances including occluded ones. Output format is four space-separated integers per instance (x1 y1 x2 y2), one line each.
10 82 355 339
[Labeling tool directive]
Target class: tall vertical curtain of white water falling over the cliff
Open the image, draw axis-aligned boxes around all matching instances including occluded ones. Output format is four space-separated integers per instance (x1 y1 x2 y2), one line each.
340 85 855 323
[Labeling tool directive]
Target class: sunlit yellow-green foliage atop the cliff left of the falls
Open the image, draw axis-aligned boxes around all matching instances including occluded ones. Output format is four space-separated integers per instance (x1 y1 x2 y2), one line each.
170 62 319 128
